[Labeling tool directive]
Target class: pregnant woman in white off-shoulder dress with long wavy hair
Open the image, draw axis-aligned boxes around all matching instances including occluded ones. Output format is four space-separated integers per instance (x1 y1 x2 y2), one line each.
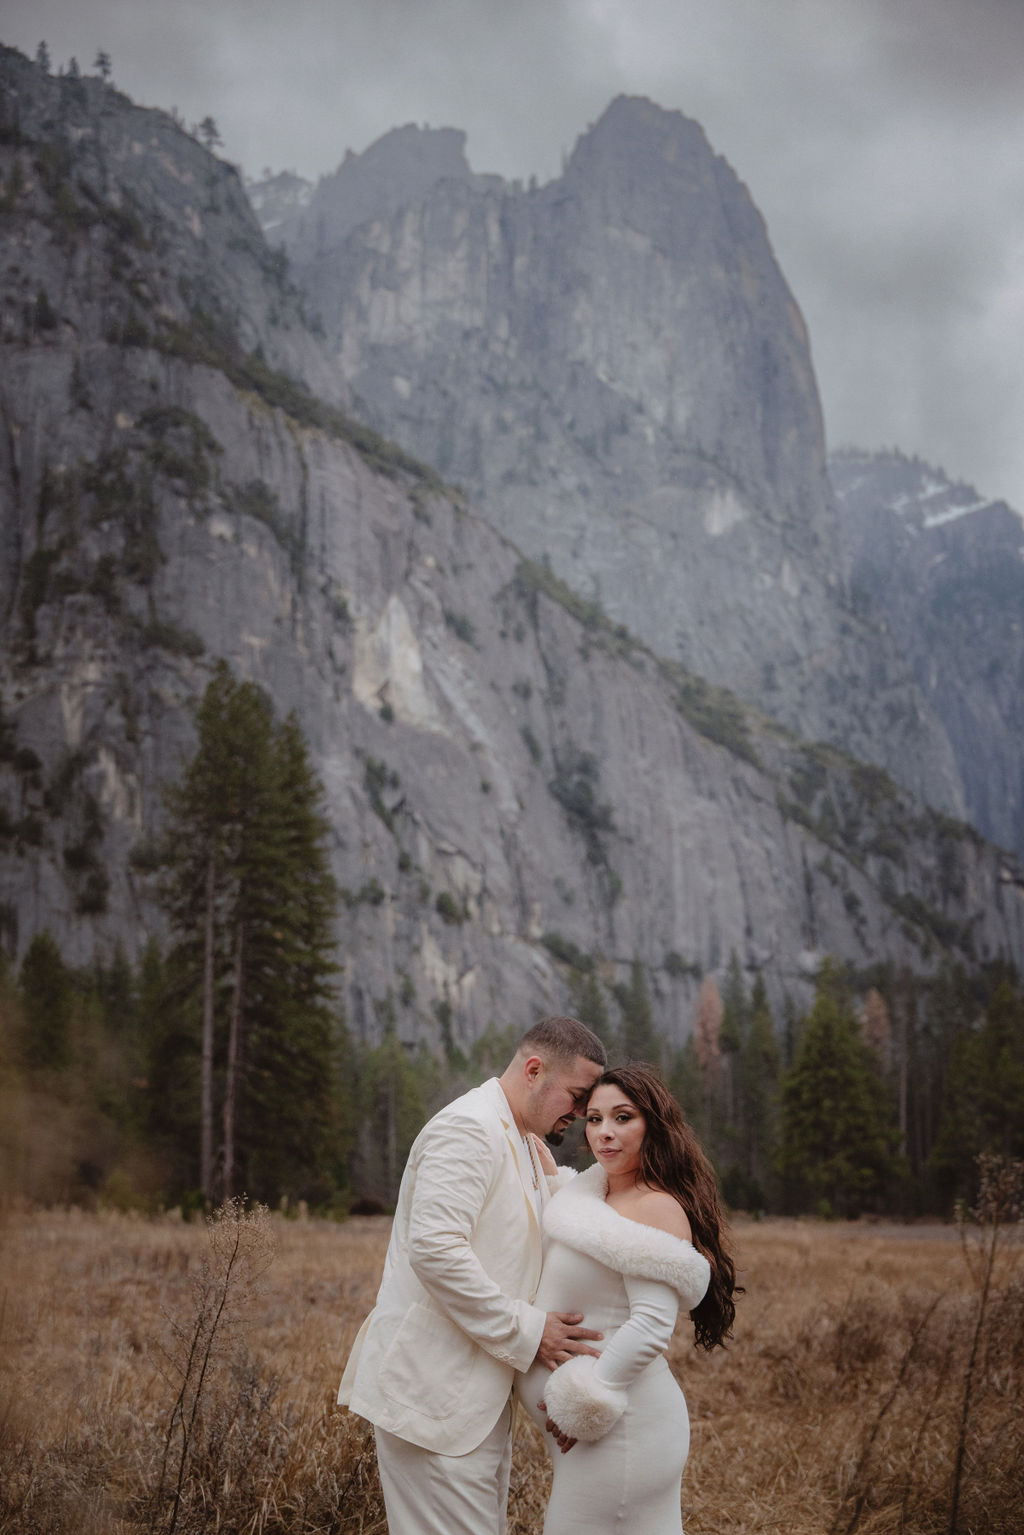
517 1065 737 1535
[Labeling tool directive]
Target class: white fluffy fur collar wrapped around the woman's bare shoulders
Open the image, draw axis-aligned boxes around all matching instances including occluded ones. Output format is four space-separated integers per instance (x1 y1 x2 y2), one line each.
543 1164 711 1311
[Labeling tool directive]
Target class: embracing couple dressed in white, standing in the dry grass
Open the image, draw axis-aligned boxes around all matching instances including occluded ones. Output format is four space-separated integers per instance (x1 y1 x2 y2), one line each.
338 1018 735 1535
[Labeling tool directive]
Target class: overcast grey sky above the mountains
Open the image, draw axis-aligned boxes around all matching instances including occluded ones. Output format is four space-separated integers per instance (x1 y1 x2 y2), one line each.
0 0 1024 511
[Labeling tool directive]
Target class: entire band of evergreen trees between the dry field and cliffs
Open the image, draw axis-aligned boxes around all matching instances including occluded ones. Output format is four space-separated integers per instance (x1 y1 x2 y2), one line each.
0 663 1024 1216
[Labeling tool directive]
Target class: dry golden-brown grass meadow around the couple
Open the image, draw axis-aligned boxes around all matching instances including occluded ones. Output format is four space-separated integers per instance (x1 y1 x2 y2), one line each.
0 1210 1024 1535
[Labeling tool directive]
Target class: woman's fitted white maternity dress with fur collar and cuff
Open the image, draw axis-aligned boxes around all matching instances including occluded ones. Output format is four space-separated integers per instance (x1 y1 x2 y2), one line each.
516 1167 711 1535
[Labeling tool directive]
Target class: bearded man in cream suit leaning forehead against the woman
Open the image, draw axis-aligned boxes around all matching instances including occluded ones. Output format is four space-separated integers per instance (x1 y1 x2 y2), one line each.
338 1018 605 1535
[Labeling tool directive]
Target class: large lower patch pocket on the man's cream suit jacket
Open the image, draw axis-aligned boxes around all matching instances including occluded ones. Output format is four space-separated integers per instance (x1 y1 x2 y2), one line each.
378 1300 477 1418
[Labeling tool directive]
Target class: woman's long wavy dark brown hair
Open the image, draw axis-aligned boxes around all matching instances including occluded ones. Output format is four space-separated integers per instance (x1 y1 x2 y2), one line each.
591 1061 743 1352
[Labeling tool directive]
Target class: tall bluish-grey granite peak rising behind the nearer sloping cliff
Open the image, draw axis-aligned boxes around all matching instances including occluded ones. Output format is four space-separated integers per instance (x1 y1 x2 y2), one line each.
269 97 964 814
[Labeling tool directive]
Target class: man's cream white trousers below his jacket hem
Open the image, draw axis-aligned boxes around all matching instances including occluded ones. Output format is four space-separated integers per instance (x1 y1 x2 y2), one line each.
373 1403 511 1535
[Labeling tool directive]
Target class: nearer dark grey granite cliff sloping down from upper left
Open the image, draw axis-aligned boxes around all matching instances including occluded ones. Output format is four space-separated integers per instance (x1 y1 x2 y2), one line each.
0 49 1024 1045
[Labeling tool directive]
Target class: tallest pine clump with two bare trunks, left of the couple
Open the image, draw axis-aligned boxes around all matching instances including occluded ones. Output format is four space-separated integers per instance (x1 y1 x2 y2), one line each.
166 663 336 1199
